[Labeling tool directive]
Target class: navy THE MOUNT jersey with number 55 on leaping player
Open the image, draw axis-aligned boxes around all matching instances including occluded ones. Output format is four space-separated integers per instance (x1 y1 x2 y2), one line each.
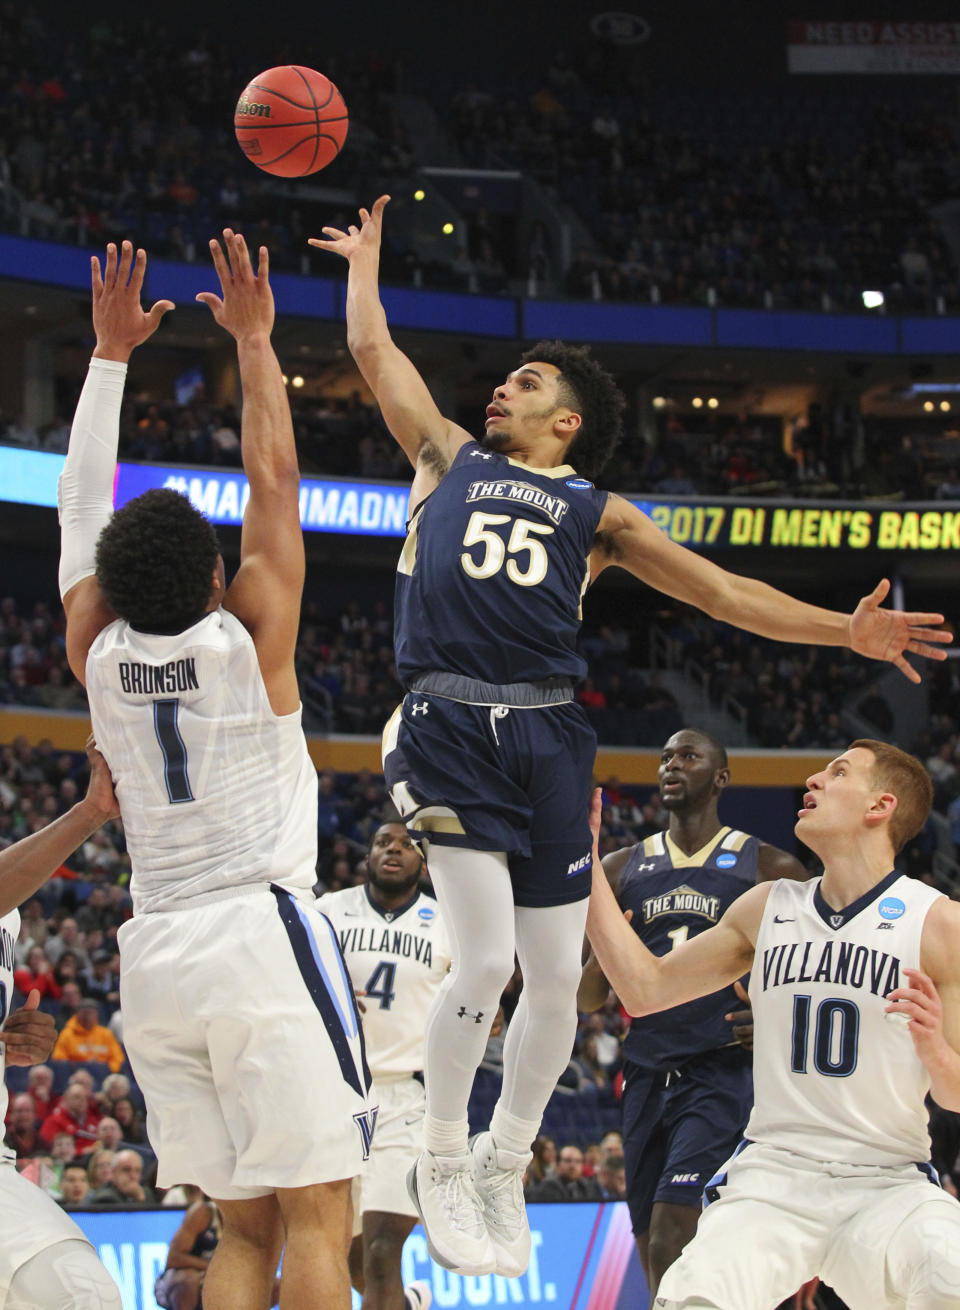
394 441 606 686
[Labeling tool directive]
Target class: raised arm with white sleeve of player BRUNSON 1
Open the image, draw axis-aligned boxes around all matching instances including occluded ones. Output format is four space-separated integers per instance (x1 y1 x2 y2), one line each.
58 241 174 683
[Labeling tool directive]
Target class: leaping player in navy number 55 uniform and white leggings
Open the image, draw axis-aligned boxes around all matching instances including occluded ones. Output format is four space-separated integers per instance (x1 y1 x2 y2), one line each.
312 197 948 1276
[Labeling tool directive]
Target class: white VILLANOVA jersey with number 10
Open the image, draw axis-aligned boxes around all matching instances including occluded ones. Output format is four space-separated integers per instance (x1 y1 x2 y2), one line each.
744 872 940 1165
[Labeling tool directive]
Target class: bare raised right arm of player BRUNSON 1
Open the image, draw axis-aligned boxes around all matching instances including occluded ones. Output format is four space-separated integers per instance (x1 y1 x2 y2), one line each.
196 228 305 714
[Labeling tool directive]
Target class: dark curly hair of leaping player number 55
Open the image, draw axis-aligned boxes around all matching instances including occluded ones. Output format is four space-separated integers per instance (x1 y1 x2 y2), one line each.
521 341 626 482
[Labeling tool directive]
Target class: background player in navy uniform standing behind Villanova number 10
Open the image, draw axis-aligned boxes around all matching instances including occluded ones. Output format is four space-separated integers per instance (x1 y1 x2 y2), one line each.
578 728 807 1303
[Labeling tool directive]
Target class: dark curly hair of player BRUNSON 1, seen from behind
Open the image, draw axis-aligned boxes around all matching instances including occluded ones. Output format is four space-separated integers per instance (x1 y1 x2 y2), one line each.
97 489 220 633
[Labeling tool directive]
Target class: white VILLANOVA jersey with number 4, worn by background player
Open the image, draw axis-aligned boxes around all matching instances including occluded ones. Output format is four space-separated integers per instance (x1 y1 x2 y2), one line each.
317 887 451 1079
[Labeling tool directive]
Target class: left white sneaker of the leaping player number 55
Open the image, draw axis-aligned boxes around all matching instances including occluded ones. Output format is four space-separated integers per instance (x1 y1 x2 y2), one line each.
407 1150 496 1275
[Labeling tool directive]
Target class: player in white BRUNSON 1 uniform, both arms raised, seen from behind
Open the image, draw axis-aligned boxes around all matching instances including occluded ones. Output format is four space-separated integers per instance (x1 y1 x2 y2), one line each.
60 241 375 1310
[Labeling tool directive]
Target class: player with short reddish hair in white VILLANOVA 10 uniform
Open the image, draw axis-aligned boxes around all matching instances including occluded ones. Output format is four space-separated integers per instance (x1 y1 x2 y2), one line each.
587 740 960 1310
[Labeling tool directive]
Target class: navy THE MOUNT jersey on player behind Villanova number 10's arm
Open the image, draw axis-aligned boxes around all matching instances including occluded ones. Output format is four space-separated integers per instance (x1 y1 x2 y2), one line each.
619 828 761 1069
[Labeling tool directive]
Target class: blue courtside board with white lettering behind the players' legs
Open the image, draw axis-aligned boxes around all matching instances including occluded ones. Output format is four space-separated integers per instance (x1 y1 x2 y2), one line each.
71 1201 650 1310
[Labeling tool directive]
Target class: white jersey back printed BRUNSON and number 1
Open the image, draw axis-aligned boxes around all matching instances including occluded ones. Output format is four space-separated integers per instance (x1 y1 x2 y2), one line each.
86 609 317 914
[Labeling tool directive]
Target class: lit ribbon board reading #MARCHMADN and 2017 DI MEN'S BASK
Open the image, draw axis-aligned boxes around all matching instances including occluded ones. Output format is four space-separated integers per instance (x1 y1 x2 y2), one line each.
0 447 960 554
